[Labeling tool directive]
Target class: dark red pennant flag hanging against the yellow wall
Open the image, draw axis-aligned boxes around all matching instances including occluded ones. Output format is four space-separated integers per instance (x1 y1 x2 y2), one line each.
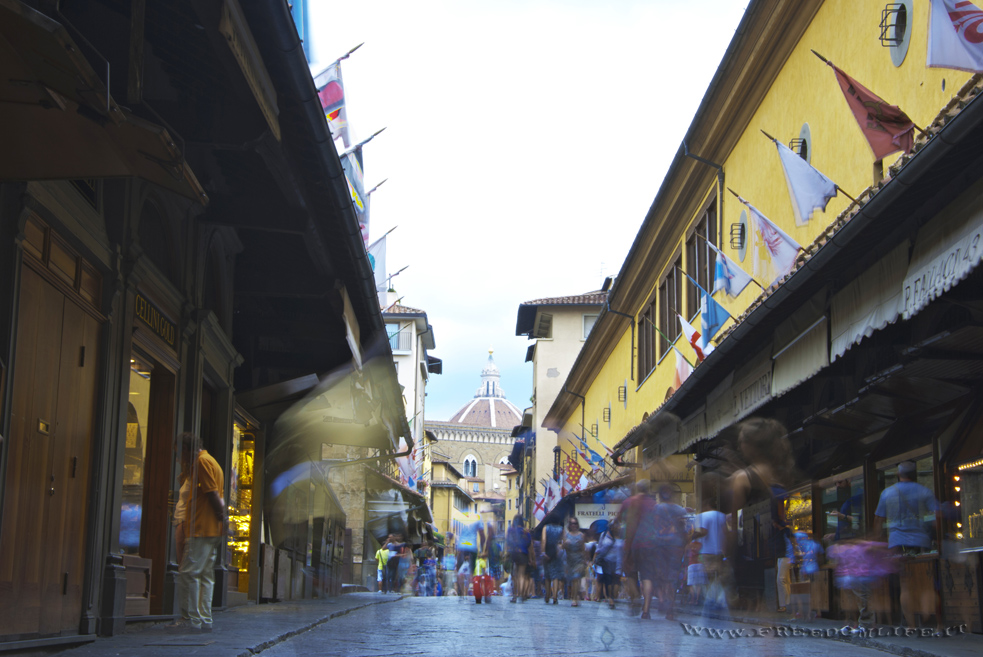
826 62 915 160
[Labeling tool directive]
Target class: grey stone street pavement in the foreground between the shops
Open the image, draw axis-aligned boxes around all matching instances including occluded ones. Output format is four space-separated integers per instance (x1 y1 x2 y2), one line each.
262 597 884 657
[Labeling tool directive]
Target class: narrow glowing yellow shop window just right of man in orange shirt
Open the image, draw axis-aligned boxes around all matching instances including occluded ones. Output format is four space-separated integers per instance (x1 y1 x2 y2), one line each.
228 422 256 592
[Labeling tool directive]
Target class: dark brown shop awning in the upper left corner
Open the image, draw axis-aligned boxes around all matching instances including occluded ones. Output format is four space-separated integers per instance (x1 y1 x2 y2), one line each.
0 0 208 204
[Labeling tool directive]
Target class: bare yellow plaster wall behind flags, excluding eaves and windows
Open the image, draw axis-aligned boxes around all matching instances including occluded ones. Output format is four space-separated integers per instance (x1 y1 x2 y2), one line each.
560 0 970 465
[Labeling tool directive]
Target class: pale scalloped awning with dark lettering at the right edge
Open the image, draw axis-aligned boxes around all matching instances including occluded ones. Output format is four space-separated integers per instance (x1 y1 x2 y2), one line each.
902 209 983 319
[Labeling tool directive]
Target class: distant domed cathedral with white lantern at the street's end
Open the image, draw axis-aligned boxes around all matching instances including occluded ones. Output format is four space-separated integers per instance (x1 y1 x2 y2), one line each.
426 351 522 491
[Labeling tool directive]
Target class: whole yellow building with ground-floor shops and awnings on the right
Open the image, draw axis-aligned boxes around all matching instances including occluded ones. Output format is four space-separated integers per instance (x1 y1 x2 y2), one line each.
544 0 983 632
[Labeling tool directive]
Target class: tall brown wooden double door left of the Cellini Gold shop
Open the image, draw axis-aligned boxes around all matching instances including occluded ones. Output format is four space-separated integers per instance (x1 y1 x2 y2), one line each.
0 267 99 636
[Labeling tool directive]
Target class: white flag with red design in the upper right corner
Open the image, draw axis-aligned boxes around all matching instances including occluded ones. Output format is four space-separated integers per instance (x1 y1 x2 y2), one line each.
927 0 983 73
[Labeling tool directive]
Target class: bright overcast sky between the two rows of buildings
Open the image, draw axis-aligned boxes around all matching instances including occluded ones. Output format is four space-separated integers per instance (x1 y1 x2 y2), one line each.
310 0 746 420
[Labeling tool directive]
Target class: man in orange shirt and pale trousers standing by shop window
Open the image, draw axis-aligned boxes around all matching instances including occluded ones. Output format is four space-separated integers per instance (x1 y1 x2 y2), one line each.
175 432 225 632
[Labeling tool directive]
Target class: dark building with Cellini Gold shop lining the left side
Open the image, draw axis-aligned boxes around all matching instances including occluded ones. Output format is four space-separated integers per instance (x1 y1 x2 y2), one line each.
0 0 412 649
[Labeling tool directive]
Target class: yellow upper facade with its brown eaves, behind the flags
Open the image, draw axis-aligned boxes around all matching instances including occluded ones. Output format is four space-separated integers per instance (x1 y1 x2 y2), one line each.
544 0 970 467
